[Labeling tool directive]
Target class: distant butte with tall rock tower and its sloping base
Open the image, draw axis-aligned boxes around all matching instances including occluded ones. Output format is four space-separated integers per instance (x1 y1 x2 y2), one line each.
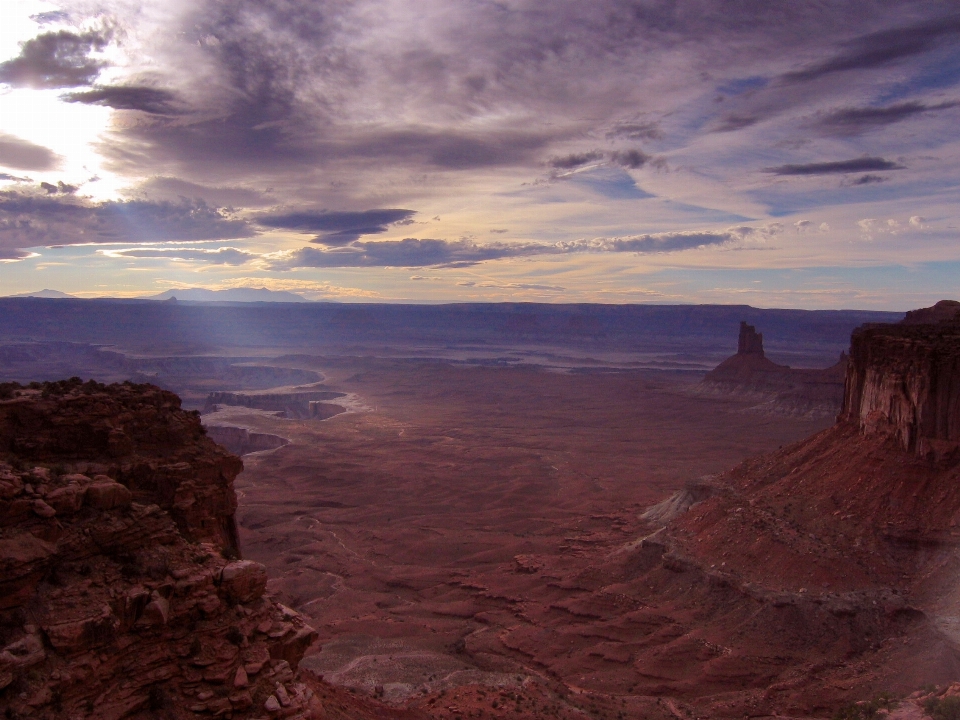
697 322 847 418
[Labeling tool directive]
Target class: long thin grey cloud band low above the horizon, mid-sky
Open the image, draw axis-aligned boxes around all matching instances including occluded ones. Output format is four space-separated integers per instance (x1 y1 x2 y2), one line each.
268 228 758 270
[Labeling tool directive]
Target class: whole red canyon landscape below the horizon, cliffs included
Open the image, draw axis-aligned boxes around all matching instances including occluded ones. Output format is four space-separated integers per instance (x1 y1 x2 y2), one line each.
0 300 960 718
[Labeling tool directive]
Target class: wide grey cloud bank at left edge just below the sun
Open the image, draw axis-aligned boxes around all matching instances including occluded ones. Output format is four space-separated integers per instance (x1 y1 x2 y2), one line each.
0 191 256 252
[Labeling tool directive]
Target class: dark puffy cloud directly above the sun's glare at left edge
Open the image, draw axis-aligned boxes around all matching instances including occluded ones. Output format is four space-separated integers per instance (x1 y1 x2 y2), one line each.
0 30 107 88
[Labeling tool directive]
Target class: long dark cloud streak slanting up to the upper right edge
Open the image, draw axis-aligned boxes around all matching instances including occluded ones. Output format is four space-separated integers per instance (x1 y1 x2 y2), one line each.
783 15 960 82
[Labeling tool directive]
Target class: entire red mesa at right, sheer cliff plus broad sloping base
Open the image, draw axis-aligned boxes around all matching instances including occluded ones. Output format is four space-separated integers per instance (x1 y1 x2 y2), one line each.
621 300 960 717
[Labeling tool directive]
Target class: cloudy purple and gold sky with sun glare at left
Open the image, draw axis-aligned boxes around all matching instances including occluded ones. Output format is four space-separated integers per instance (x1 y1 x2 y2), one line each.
0 0 960 310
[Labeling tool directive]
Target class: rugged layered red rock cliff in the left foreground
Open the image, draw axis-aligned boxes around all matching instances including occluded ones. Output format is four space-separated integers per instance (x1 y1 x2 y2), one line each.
0 379 321 719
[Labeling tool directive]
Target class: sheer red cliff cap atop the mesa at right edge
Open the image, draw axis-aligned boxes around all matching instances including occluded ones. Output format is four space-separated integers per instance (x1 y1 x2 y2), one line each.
841 301 960 458
